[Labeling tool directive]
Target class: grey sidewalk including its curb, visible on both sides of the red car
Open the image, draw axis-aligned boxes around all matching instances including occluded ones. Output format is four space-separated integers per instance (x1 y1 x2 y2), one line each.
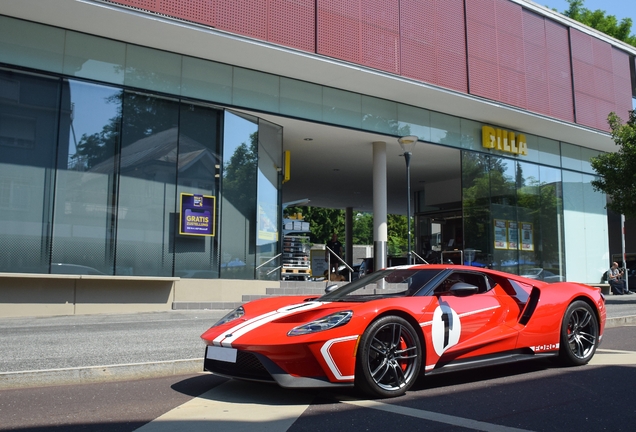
0 295 636 390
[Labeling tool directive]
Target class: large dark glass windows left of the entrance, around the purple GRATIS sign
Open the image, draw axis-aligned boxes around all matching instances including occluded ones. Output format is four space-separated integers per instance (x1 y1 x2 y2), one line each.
0 69 282 279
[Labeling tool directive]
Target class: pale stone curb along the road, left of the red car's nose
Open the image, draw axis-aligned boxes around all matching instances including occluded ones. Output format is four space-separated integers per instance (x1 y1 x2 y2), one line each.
0 358 203 390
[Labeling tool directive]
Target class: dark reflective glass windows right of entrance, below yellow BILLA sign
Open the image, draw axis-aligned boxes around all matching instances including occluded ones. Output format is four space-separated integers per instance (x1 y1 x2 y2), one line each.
462 151 566 281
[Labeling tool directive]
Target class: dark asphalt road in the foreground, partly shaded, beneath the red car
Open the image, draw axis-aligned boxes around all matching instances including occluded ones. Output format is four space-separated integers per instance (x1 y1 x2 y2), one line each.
0 326 636 432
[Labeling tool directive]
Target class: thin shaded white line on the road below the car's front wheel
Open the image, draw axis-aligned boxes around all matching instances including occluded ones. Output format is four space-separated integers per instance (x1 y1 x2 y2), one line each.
342 400 528 432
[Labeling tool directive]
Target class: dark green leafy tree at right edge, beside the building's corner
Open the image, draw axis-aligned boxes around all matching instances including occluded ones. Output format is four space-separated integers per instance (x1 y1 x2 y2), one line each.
591 111 636 218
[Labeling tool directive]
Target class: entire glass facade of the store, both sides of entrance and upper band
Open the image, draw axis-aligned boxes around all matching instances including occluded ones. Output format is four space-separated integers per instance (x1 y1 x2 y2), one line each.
0 16 608 282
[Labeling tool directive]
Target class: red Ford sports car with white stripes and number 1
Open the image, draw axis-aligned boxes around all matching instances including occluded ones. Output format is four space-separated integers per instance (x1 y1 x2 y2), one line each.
201 265 605 397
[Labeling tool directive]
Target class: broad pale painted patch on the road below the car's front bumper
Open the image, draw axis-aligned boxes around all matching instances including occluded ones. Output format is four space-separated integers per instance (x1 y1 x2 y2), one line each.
137 380 312 432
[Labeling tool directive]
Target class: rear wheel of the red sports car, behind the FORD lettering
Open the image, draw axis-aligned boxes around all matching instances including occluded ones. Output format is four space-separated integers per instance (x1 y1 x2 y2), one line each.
559 300 599 366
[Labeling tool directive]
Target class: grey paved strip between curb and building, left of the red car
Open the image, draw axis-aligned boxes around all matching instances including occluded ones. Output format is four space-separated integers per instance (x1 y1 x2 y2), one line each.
0 310 228 373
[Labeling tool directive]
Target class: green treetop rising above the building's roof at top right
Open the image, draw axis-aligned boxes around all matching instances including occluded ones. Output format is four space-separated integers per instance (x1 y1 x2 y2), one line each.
563 0 636 46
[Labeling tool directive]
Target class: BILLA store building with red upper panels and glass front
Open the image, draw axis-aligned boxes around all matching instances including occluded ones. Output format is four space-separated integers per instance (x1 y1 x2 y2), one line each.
0 0 636 316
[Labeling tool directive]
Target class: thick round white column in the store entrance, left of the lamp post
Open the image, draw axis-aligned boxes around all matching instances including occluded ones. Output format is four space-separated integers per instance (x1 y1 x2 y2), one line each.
373 141 388 269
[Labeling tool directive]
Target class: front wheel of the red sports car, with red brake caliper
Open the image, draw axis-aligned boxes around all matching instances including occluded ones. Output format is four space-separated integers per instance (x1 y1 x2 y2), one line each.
355 315 422 398
